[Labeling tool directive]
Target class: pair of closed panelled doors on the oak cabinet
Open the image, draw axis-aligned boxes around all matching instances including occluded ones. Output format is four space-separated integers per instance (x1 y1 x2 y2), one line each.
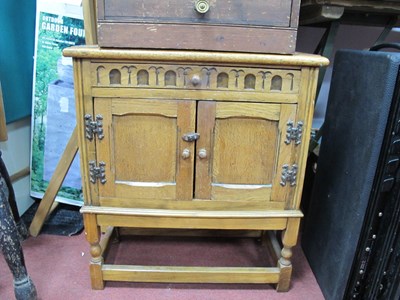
94 98 297 202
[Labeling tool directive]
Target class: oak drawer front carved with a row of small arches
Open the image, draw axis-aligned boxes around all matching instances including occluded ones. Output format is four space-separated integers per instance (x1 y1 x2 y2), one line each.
92 63 300 93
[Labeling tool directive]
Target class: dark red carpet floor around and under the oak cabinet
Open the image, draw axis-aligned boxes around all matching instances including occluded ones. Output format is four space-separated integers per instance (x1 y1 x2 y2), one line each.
0 234 324 300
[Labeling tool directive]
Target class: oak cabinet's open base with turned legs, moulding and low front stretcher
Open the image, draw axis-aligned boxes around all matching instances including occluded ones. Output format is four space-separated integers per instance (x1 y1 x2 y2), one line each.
81 206 302 292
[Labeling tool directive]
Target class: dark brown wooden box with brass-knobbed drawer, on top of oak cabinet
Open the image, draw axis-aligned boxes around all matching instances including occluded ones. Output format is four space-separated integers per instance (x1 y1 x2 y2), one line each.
97 0 300 53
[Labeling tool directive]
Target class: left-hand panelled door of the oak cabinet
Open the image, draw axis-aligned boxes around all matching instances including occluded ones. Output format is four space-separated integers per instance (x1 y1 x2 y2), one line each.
94 98 196 200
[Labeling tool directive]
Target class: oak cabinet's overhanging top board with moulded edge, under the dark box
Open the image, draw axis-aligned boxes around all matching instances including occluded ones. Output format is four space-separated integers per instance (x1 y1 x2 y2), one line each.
63 46 329 67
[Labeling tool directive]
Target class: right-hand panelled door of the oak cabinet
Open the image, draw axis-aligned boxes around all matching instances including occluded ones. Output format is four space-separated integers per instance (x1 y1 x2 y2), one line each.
195 101 297 201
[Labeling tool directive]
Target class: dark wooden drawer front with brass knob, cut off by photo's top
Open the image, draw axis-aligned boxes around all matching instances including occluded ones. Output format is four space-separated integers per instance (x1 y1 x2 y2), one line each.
99 0 292 27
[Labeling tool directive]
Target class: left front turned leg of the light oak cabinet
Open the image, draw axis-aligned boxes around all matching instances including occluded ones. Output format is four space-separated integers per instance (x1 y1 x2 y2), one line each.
83 214 104 290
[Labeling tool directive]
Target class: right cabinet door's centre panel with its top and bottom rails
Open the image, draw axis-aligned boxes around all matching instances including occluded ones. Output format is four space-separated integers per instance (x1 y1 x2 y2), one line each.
209 102 280 201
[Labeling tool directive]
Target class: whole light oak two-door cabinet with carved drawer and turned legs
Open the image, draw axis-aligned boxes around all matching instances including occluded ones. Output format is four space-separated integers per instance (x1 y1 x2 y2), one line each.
64 47 327 291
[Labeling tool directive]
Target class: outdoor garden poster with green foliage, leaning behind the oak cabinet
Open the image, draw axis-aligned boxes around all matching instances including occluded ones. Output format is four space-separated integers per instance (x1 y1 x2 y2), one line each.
31 0 85 205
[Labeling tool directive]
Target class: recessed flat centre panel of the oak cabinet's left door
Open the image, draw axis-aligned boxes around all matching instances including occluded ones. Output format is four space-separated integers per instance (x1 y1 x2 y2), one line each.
111 108 178 183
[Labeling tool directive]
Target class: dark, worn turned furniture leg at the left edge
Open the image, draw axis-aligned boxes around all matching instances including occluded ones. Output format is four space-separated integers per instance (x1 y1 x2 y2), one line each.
0 173 37 300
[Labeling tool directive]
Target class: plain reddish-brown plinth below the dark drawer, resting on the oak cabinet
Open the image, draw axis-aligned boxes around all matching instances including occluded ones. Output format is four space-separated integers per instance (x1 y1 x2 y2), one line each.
98 23 297 54
